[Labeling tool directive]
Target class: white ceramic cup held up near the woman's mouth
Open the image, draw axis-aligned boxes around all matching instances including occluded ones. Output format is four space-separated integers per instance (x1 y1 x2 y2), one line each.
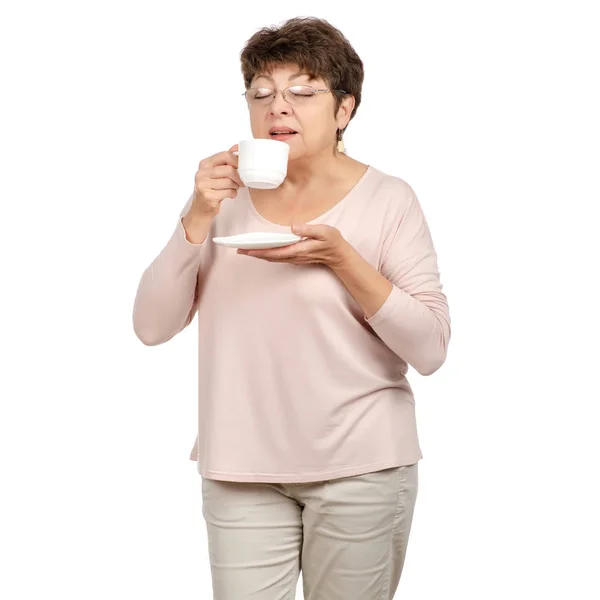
237 138 290 190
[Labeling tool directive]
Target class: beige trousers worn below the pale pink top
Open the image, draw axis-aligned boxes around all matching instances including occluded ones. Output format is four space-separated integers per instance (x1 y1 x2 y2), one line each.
202 463 418 600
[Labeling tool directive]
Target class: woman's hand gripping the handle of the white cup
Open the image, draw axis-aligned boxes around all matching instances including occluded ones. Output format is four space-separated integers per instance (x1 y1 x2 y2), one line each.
190 144 245 218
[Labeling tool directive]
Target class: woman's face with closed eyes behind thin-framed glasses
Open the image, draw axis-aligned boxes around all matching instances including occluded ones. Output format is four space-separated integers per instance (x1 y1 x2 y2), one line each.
248 65 354 160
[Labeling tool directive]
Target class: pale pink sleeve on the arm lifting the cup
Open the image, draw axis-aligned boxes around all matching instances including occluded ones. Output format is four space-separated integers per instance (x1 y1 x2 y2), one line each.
133 196 208 346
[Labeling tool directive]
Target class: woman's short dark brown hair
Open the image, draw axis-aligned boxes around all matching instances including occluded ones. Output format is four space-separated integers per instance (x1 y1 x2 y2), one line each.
240 17 364 141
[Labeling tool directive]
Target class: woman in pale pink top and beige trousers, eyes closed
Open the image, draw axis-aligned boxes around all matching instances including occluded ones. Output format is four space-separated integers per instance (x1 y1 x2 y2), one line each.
133 18 450 600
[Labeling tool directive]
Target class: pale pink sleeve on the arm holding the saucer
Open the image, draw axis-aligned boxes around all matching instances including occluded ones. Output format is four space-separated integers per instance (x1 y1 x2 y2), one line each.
366 185 451 375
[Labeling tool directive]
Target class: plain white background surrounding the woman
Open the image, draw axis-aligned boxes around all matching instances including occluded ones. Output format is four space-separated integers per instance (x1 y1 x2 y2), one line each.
0 0 600 600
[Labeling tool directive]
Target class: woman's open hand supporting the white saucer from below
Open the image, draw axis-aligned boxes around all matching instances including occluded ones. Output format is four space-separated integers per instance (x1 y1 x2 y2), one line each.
238 225 349 268
